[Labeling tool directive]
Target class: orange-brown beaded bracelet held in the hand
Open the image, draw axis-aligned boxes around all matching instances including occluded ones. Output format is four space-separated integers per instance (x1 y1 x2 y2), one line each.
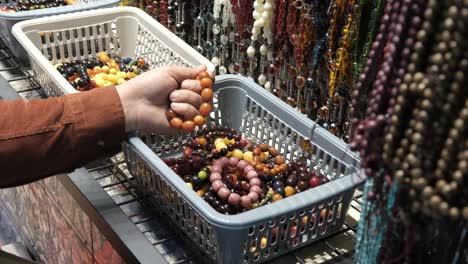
166 72 213 132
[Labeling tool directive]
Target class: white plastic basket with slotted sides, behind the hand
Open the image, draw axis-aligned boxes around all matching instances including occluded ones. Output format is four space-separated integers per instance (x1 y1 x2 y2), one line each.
13 7 214 96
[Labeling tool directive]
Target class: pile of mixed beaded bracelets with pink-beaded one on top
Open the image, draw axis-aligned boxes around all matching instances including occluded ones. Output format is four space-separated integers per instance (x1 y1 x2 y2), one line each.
164 127 328 214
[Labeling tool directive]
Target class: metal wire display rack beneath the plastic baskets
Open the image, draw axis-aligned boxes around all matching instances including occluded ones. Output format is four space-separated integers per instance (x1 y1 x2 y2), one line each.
0 38 362 264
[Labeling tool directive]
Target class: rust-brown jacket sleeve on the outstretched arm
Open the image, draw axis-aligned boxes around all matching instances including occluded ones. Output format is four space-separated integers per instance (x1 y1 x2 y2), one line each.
0 87 125 188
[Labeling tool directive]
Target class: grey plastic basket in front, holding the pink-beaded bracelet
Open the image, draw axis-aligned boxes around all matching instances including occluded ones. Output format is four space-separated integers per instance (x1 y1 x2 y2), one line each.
124 75 364 263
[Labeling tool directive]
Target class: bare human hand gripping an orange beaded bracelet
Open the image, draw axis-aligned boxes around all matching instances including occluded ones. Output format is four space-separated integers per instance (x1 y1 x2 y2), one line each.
117 66 206 134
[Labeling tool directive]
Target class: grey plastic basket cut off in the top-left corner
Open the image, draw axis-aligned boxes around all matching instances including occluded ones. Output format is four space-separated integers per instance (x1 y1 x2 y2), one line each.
0 0 121 62
